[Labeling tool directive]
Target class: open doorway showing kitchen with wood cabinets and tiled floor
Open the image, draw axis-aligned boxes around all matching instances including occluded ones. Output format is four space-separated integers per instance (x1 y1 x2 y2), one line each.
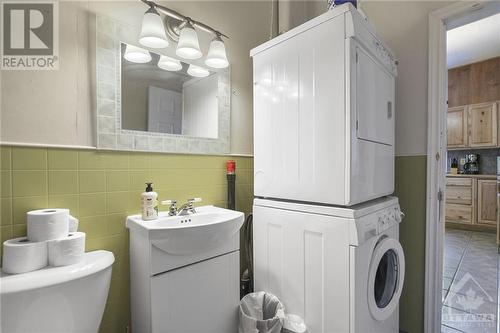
441 8 500 333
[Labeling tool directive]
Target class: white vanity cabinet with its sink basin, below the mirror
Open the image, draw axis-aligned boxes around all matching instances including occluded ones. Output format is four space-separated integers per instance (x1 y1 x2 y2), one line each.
127 206 243 333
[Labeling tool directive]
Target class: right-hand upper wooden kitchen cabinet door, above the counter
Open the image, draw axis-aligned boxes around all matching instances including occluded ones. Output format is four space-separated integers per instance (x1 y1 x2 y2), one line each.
467 102 498 147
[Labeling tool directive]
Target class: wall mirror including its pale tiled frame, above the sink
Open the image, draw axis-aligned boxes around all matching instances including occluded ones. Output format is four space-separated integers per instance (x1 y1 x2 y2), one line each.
96 16 231 154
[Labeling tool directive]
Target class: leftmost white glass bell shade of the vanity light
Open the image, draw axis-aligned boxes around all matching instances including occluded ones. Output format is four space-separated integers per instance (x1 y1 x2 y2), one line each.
139 6 169 49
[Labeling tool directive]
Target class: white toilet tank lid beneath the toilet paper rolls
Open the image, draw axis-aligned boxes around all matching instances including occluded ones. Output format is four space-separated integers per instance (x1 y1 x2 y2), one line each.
0 250 115 295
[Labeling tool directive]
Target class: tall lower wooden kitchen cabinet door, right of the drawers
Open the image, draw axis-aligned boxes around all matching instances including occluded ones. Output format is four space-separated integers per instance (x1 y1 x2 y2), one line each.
477 179 498 226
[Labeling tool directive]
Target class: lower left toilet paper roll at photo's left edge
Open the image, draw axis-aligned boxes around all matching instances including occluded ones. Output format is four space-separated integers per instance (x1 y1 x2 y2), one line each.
2 237 48 274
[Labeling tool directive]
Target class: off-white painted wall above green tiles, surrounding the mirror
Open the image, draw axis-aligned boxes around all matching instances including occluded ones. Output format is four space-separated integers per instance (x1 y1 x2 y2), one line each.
0 0 278 154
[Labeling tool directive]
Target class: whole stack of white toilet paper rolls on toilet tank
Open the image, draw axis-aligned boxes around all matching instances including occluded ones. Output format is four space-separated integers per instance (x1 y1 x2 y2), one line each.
2 209 85 274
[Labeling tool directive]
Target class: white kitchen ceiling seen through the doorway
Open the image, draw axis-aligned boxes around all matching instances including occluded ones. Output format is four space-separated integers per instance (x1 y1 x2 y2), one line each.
447 13 500 68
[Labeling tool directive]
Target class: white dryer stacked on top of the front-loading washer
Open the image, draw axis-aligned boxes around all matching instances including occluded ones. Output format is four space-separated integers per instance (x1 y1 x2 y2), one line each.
250 4 396 206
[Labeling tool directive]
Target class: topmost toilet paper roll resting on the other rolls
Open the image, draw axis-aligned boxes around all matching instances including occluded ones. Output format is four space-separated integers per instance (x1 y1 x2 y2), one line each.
28 209 69 242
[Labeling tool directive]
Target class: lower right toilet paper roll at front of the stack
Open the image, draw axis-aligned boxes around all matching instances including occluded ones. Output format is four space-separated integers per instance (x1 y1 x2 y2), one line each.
47 232 85 266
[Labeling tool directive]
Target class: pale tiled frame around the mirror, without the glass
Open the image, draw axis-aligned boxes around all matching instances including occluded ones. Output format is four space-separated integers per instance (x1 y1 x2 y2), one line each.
95 15 231 155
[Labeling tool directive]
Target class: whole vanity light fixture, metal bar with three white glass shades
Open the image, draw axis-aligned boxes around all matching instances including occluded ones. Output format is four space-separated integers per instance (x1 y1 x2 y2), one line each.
139 0 229 65
